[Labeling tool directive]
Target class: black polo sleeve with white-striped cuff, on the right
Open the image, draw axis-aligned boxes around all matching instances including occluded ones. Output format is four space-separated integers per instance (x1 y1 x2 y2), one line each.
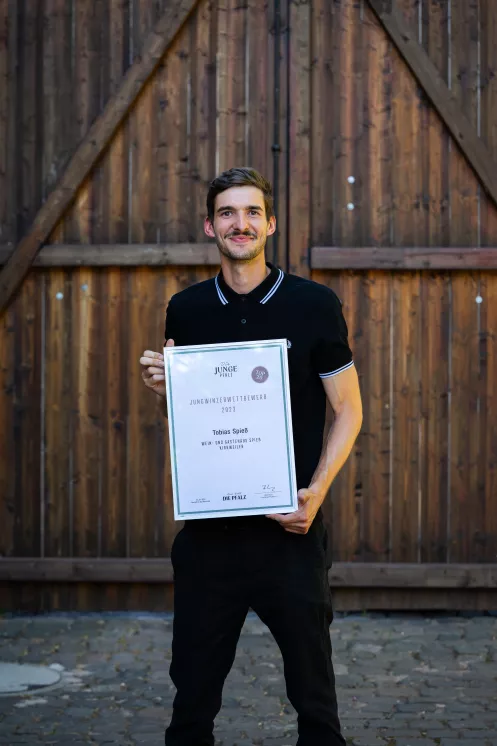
313 291 354 378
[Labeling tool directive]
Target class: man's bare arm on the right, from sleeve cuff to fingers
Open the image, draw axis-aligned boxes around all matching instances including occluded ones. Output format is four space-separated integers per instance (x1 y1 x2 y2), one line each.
268 366 362 534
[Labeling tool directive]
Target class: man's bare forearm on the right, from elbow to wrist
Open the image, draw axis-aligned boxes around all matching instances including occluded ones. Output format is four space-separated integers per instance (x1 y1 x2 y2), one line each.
309 404 362 500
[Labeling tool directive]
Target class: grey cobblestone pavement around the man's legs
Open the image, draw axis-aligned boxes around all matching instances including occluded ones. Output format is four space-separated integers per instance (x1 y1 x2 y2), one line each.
0 614 497 746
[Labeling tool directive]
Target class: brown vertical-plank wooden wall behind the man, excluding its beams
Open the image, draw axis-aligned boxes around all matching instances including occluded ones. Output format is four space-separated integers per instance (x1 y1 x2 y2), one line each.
0 0 497 609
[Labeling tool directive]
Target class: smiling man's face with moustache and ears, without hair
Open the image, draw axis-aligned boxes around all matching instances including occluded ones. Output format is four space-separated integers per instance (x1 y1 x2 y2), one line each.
204 186 276 262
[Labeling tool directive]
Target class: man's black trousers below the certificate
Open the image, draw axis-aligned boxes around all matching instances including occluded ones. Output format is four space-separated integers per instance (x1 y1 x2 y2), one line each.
165 514 345 746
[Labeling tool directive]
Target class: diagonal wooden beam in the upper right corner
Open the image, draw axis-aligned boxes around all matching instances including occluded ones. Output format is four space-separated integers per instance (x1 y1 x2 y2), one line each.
368 0 497 212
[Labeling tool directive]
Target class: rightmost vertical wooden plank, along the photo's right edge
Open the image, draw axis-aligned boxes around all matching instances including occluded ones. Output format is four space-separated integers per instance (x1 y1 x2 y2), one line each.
474 0 497 562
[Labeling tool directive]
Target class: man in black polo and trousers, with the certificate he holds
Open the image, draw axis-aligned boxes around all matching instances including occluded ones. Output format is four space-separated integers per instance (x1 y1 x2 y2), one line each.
140 168 362 746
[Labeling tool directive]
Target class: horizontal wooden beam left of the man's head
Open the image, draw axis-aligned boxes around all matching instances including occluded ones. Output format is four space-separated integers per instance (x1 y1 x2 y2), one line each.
0 243 219 267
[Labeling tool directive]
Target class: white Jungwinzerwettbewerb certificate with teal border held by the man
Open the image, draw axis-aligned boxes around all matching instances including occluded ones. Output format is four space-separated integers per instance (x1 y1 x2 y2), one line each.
164 339 298 520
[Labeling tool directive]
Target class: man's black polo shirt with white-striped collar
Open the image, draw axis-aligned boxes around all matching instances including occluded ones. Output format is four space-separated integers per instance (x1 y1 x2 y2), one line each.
165 264 353 500
